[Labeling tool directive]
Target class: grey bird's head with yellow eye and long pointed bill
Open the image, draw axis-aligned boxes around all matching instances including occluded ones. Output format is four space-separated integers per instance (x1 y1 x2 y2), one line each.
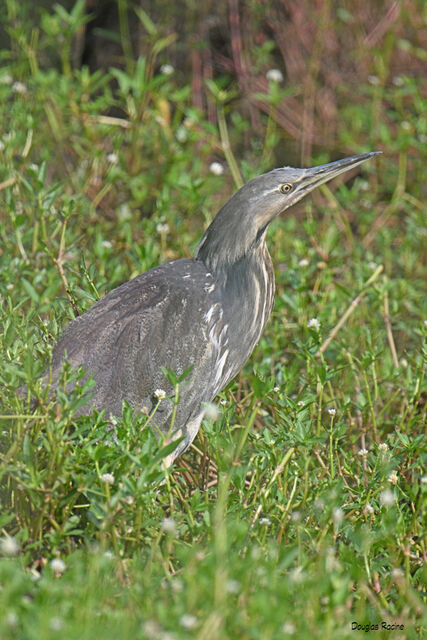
195 151 381 271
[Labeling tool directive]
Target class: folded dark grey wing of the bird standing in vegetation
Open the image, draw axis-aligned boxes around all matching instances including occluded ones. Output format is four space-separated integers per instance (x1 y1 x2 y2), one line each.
52 260 217 426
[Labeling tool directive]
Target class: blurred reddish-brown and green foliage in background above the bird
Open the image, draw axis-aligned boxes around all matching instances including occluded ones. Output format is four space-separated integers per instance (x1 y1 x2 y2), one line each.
0 0 426 164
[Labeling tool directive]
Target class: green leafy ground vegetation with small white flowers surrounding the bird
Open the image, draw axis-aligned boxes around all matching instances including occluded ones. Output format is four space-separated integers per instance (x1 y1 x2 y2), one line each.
0 0 427 640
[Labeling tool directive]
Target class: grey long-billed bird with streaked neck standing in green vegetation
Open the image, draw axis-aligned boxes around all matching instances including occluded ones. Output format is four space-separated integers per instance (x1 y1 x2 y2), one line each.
51 151 381 466
